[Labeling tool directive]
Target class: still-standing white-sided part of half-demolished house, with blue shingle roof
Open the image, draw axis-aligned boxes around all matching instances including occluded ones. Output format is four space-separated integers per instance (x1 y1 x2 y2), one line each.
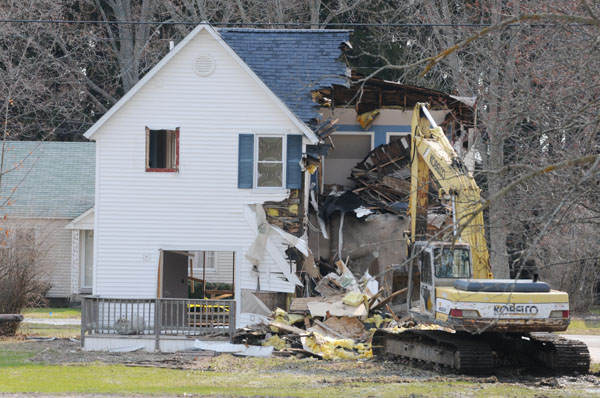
82 21 349 338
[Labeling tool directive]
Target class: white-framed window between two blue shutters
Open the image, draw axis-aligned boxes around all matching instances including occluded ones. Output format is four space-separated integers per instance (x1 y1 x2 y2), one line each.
256 136 283 188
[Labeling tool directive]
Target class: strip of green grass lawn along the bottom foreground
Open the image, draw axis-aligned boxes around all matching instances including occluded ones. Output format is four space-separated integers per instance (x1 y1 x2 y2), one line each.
0 359 585 398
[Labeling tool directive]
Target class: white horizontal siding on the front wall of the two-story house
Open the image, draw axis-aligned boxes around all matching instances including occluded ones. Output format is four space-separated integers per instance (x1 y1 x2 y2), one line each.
94 28 298 298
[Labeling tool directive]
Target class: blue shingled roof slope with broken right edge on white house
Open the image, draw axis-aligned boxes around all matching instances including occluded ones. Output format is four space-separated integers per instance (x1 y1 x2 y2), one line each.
218 28 350 123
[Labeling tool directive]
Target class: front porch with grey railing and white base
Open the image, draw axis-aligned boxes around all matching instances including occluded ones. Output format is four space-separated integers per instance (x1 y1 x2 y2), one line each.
81 297 236 352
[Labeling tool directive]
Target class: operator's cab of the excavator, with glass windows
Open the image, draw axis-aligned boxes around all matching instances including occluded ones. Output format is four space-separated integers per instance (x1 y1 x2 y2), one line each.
408 241 473 319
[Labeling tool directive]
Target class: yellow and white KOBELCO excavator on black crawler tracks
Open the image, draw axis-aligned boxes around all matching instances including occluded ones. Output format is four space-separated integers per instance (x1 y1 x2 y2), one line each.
373 103 590 373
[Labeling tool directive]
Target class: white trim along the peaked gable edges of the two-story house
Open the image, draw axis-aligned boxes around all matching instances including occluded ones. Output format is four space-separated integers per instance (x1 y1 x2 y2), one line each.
84 24 338 144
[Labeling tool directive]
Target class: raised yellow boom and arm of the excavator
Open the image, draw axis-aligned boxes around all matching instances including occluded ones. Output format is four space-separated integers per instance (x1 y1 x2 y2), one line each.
409 103 492 279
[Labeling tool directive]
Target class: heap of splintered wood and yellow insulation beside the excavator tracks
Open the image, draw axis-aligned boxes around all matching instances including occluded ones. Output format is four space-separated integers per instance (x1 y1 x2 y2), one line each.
229 261 431 360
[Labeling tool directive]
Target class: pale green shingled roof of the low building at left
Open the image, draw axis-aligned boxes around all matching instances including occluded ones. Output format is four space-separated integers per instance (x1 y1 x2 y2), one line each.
0 141 96 218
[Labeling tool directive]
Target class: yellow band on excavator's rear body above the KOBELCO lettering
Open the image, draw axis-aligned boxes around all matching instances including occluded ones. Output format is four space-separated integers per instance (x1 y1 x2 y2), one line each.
435 287 569 304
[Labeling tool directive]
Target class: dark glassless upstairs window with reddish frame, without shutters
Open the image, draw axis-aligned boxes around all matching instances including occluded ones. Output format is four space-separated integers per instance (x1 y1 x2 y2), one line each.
146 127 179 172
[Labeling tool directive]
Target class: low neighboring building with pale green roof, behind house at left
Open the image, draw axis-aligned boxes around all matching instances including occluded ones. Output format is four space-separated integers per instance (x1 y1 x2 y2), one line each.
0 141 95 301
